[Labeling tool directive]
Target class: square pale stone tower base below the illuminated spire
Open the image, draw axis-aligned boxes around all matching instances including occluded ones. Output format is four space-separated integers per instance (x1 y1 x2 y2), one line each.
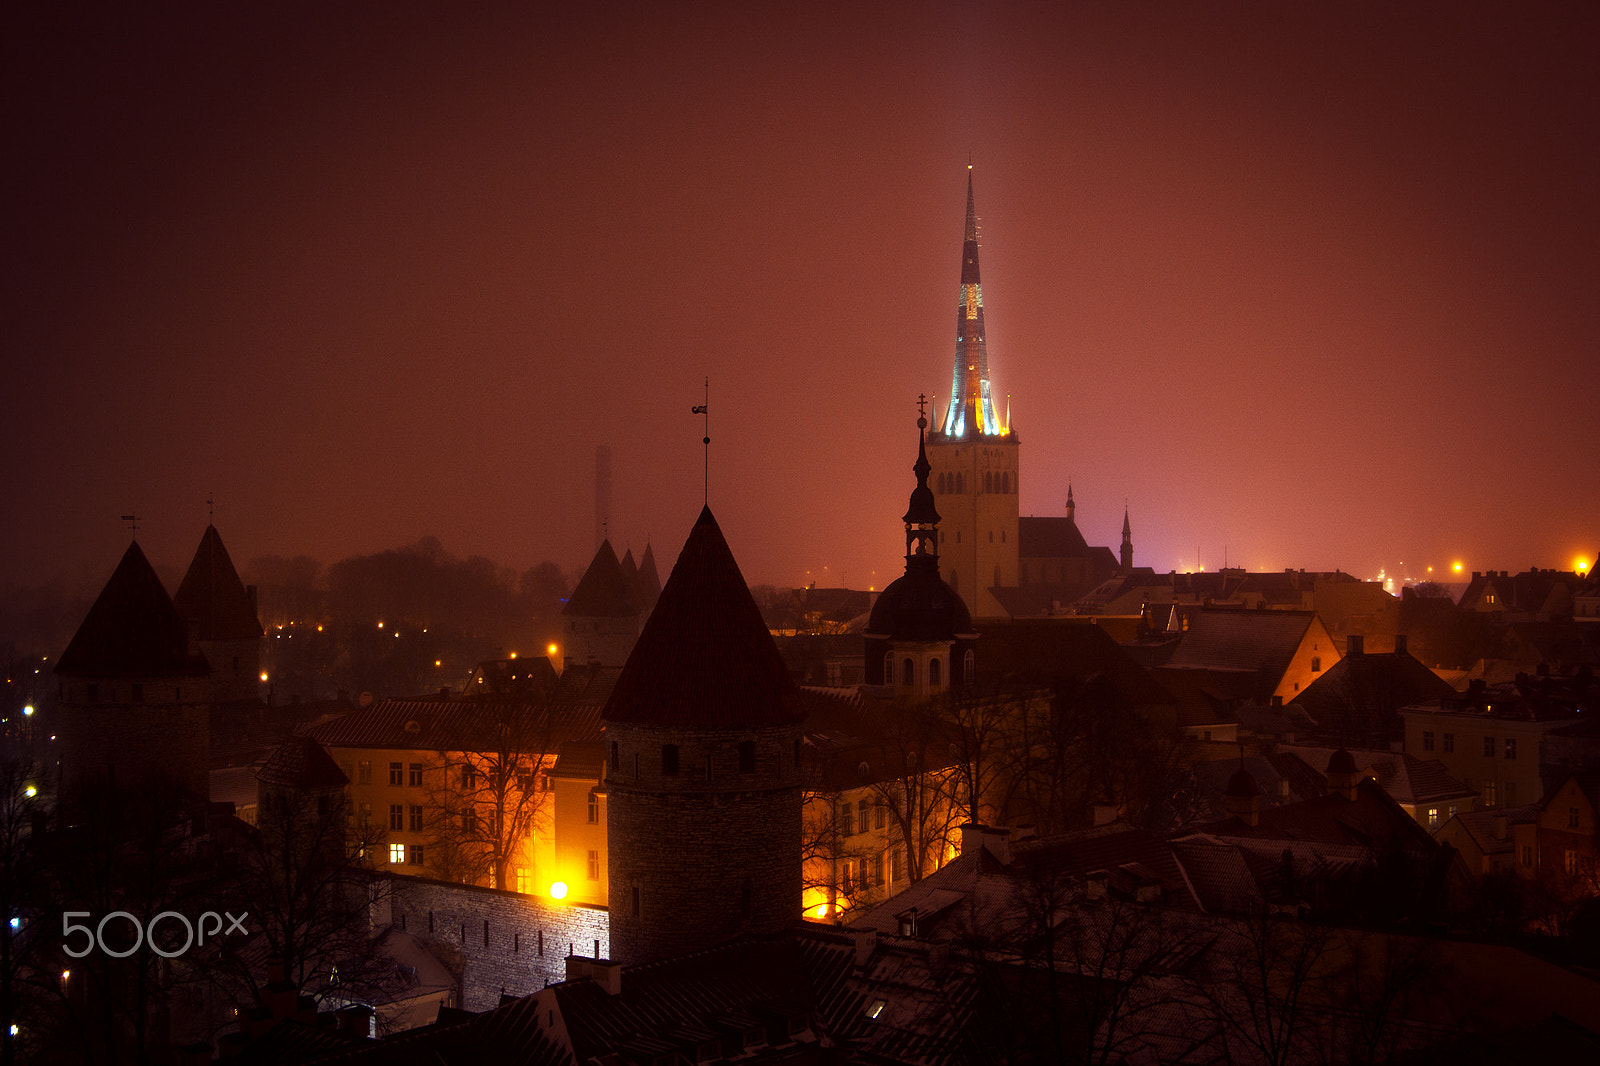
926 437 1021 618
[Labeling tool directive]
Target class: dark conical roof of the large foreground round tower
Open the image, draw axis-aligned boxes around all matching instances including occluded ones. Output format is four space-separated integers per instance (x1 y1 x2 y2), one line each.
605 507 805 728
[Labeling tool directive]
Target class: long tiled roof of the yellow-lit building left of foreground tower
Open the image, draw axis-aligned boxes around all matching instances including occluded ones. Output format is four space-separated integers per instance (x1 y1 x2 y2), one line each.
307 699 600 752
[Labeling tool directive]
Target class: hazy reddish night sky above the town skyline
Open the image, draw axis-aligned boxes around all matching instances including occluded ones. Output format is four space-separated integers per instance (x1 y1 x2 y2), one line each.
0 0 1600 601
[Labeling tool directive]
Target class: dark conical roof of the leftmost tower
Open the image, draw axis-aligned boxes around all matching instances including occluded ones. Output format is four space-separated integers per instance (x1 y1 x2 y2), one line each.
56 541 211 677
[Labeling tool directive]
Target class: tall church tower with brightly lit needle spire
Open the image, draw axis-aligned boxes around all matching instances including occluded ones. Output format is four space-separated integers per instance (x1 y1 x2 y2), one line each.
926 166 1021 618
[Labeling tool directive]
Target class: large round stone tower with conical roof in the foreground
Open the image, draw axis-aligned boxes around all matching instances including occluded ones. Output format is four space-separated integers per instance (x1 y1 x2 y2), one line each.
602 507 805 965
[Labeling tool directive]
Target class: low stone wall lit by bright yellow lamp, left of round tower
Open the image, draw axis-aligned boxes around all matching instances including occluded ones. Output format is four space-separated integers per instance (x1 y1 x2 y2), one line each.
384 877 611 1012
